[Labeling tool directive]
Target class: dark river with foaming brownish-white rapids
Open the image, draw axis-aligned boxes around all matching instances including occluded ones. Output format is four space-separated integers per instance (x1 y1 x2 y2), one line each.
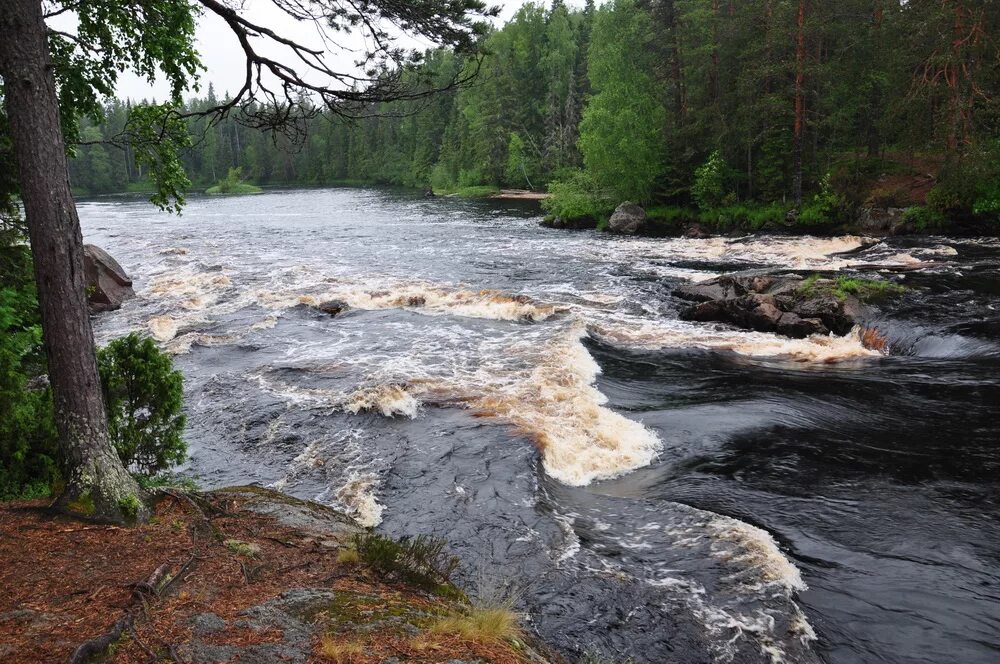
80 189 1000 664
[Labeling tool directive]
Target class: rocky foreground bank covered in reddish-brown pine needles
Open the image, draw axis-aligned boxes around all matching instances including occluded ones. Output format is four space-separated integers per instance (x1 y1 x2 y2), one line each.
0 487 552 664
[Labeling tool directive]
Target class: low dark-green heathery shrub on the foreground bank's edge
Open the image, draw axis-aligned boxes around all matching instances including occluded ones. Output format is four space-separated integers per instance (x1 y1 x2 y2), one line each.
354 531 459 592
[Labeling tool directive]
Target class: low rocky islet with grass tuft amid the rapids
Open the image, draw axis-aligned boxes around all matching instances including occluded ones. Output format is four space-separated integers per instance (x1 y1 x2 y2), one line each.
674 275 863 339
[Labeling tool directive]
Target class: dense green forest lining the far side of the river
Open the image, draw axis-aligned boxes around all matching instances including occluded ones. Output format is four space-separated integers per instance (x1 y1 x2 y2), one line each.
71 0 1000 223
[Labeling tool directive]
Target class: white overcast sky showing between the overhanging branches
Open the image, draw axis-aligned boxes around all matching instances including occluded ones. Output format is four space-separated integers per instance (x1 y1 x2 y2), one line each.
118 0 584 100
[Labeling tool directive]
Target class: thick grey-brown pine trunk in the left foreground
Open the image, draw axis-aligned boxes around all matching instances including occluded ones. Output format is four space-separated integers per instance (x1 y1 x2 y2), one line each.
0 0 146 522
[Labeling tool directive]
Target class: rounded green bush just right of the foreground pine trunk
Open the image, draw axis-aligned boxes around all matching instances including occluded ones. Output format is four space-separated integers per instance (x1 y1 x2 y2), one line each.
98 333 187 475
